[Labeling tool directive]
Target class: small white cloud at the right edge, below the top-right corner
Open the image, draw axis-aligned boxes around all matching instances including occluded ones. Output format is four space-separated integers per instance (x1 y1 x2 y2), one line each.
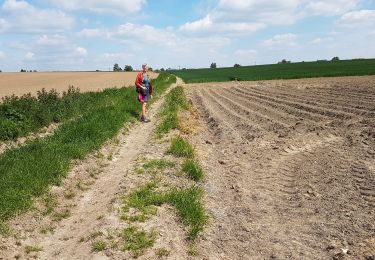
338 10 375 28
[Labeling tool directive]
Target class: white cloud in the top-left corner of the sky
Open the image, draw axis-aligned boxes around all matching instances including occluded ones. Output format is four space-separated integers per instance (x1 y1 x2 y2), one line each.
0 0 74 33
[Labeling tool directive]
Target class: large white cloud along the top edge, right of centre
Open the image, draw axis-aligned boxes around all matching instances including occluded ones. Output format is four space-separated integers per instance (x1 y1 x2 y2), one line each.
180 0 361 34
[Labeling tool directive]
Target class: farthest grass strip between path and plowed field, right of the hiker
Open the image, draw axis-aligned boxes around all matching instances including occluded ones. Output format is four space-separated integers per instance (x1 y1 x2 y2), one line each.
156 86 190 138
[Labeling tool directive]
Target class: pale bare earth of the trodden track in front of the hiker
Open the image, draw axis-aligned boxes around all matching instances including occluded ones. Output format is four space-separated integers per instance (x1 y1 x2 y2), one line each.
0 78 191 260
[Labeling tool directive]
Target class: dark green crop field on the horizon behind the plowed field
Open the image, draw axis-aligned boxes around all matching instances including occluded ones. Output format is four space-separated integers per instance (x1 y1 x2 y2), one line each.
172 59 375 83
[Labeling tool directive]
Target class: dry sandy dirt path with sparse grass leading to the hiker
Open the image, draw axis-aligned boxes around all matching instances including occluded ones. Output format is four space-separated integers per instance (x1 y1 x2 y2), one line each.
0 80 191 260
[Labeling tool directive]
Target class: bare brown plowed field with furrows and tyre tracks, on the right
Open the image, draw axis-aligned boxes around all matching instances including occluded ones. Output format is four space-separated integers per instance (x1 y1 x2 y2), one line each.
186 77 375 259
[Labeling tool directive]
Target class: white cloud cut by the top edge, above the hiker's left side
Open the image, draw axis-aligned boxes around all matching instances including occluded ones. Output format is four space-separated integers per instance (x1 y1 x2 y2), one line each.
52 0 147 15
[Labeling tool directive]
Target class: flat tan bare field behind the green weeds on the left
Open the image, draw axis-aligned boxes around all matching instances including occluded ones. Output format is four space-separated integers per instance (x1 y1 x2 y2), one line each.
0 72 157 98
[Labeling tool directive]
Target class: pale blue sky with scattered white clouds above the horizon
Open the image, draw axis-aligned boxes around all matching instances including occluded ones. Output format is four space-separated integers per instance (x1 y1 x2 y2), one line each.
0 0 375 72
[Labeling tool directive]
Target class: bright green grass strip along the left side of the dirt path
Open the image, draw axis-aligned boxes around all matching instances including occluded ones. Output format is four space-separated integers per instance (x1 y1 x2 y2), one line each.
0 75 175 221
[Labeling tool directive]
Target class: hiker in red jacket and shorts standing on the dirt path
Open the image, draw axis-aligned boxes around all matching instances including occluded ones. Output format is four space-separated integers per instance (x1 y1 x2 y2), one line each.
135 64 152 123
